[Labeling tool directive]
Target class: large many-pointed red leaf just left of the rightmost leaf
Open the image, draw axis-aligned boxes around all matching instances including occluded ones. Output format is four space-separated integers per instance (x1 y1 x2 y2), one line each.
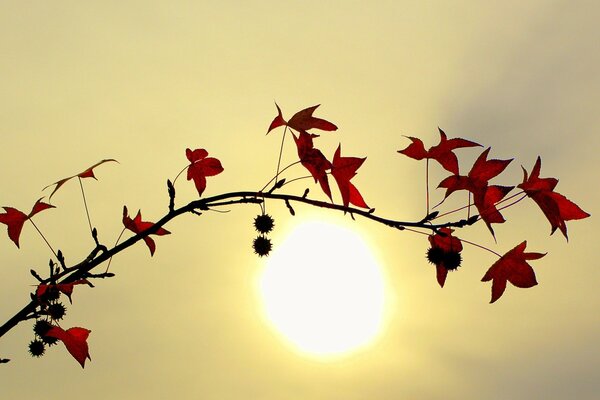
438 147 513 235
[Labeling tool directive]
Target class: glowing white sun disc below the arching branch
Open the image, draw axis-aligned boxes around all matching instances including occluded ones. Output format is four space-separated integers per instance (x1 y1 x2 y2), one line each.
258 221 385 358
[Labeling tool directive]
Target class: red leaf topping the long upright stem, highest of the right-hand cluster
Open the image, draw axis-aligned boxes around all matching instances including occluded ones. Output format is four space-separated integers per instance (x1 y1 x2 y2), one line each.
398 128 481 175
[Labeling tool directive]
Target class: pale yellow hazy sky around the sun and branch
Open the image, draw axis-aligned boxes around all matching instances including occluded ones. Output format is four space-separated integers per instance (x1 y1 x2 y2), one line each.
0 0 600 399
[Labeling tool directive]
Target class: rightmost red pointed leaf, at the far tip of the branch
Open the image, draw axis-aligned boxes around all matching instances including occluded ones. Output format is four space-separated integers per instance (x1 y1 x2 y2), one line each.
517 156 590 240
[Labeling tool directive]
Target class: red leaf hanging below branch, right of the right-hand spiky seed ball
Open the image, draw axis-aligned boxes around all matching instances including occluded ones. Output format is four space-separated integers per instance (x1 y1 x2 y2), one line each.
481 241 546 303
